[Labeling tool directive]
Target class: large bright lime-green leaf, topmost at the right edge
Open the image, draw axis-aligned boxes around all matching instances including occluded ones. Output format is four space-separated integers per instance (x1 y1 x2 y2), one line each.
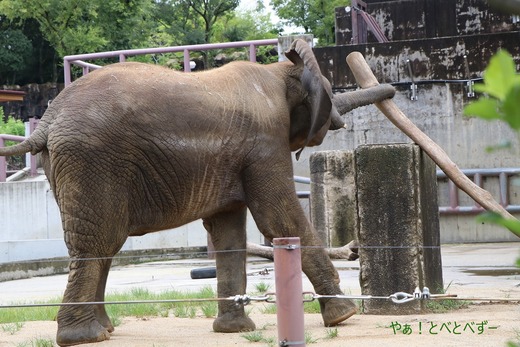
475 50 517 100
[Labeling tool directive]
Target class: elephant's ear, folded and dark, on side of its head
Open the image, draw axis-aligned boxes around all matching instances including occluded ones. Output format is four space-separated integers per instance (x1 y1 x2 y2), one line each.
285 40 332 159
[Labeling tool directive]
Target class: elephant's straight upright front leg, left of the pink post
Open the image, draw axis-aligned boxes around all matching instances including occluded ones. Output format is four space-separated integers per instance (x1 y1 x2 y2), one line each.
204 207 255 333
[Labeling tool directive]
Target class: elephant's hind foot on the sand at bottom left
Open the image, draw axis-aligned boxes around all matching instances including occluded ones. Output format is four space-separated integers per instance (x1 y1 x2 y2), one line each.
56 320 113 347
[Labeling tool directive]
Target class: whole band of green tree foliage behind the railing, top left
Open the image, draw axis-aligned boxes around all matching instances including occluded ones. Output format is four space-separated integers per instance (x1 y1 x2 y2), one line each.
0 0 349 83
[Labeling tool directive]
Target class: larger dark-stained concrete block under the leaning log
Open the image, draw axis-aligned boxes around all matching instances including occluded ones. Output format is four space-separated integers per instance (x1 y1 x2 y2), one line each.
355 144 443 314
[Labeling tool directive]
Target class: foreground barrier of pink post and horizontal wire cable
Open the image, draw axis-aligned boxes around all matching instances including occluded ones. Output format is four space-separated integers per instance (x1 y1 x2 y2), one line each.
0 242 520 347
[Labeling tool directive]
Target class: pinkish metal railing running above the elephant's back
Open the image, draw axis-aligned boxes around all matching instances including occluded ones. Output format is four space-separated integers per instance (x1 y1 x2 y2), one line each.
63 39 278 86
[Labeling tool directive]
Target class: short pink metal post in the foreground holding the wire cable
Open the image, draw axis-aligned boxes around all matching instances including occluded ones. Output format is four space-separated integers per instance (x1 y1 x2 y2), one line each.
273 237 305 346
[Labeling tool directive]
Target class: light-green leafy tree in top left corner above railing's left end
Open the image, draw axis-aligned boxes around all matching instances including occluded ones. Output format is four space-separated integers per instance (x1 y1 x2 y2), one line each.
0 0 151 82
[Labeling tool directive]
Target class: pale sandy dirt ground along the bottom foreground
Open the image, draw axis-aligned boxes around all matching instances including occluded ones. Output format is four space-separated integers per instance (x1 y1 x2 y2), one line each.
0 303 520 347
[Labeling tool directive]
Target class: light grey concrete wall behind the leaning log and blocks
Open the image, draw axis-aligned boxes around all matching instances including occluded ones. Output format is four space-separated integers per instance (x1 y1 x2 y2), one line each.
294 84 520 243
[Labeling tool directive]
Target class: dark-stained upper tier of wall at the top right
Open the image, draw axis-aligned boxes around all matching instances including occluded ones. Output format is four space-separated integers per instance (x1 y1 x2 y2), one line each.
336 0 520 45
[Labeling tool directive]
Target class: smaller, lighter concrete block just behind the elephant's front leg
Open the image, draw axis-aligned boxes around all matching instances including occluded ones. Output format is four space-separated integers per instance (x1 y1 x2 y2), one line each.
310 151 358 247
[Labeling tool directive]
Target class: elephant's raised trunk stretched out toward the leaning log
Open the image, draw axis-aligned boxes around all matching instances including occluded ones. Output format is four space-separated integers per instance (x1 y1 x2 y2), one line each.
331 84 395 115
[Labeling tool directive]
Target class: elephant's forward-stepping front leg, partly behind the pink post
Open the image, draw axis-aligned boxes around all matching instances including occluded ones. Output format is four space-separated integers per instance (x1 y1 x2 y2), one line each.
246 160 357 326
